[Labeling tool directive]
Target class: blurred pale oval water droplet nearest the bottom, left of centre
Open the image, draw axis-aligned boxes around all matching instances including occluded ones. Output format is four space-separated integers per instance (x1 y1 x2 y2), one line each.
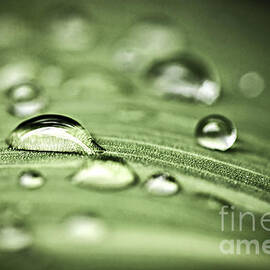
63 214 107 244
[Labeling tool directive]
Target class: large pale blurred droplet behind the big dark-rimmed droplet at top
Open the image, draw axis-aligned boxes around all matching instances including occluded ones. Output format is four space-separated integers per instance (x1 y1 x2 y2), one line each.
114 18 186 71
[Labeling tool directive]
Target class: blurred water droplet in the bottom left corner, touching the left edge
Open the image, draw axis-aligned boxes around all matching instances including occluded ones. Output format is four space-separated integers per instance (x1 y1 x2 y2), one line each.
0 205 32 252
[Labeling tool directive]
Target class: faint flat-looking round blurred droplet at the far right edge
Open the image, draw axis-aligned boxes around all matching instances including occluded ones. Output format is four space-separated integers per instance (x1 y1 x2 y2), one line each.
239 72 265 98
